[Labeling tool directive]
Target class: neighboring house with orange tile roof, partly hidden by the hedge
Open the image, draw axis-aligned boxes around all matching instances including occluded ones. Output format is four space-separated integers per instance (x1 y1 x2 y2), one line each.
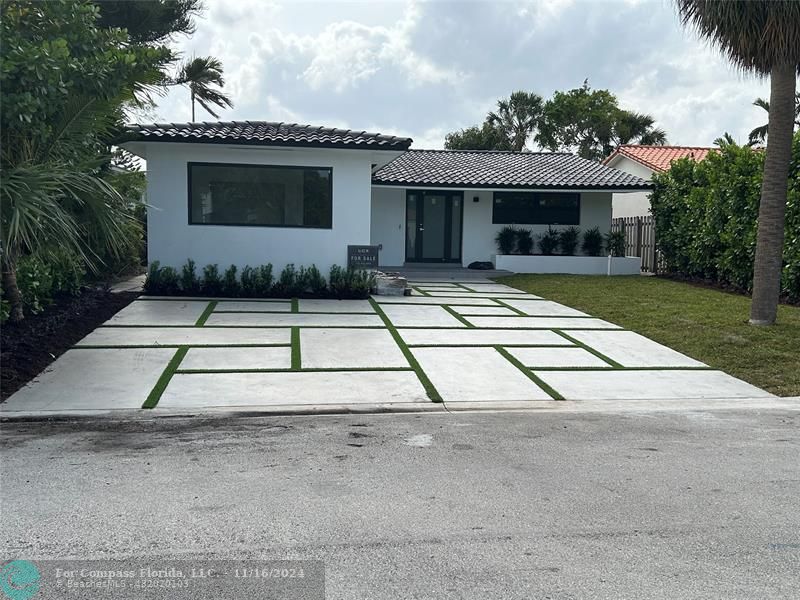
603 144 713 219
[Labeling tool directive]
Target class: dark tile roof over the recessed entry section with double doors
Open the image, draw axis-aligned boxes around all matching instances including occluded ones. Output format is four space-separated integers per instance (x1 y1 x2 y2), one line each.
372 150 652 190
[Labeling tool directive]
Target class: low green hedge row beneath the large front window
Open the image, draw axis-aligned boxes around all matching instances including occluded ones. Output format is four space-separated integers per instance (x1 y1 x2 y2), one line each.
144 259 375 299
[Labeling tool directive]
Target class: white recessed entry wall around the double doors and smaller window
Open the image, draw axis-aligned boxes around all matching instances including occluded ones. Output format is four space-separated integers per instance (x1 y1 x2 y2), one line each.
371 187 612 266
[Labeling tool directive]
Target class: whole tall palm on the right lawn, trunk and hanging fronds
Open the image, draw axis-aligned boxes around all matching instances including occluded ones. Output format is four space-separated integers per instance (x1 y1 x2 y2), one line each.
675 0 800 325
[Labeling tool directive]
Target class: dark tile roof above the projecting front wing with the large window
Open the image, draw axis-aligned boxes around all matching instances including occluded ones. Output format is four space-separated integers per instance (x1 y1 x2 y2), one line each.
123 121 411 150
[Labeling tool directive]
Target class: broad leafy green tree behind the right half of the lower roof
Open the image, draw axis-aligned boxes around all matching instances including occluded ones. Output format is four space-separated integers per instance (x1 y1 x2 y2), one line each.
536 81 667 160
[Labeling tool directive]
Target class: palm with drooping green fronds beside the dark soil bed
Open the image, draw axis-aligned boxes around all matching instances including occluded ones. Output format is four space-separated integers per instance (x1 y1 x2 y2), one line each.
0 97 139 322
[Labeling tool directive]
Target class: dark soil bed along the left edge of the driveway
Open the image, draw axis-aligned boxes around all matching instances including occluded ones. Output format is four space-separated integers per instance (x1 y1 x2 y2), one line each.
0 288 139 401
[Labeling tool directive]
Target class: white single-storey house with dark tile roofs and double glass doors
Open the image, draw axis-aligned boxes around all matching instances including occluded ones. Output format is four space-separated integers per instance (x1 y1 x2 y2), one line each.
122 121 650 272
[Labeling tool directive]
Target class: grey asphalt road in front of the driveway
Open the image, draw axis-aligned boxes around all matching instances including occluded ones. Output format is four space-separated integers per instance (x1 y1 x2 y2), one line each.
0 410 800 600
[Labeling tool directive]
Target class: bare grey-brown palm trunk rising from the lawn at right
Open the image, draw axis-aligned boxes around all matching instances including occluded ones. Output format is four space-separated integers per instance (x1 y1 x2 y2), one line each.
750 64 796 325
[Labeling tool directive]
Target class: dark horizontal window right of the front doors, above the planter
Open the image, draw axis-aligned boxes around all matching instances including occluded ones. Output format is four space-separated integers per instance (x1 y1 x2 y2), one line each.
492 192 581 225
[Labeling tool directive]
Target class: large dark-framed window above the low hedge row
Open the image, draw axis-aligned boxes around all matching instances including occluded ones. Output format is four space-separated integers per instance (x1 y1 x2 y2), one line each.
189 163 333 229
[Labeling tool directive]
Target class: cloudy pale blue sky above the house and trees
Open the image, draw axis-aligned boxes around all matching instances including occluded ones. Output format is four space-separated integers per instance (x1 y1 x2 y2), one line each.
150 0 769 148
